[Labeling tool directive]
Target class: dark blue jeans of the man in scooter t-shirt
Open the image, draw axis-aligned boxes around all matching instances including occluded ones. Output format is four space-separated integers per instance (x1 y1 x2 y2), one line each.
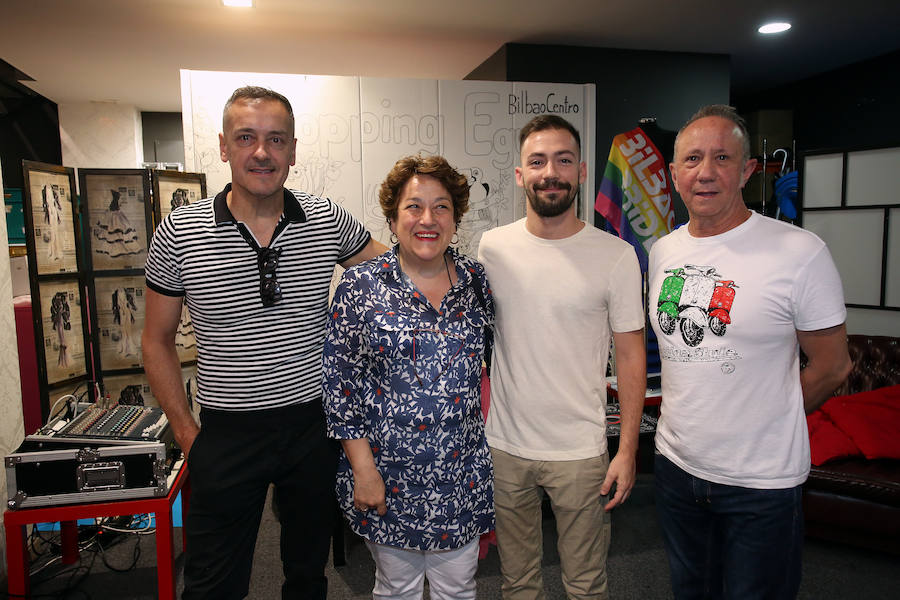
654 453 803 600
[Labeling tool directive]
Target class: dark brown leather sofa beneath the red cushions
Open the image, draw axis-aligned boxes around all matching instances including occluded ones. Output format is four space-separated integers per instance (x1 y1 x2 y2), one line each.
803 335 900 554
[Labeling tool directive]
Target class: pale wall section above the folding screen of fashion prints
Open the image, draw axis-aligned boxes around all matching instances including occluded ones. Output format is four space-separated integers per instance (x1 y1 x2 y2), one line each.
59 102 144 169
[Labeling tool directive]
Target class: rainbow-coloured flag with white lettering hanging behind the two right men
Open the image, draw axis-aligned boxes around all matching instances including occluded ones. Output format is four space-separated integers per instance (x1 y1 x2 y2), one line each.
594 127 675 272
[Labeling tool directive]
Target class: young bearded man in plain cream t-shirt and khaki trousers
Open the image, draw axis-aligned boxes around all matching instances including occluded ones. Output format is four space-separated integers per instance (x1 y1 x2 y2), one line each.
478 115 646 600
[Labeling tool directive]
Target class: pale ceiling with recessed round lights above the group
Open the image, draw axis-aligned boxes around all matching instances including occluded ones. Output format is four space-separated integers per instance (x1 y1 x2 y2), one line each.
0 0 900 111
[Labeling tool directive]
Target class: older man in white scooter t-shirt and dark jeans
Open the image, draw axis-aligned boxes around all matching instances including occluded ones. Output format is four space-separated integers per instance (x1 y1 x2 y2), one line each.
648 105 850 600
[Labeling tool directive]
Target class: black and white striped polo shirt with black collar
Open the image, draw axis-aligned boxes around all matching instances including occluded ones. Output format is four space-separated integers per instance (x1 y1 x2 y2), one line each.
146 184 370 410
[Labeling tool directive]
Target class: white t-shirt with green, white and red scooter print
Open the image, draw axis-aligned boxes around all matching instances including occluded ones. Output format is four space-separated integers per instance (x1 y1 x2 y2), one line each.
648 213 846 489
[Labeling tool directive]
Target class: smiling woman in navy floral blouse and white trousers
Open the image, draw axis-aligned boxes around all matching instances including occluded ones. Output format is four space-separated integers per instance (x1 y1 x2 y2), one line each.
323 156 494 600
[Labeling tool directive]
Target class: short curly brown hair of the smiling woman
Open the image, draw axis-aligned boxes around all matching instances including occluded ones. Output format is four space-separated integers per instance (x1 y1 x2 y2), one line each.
378 155 469 226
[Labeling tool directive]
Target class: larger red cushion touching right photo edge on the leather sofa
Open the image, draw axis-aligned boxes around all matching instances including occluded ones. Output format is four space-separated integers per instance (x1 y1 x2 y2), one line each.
821 385 900 459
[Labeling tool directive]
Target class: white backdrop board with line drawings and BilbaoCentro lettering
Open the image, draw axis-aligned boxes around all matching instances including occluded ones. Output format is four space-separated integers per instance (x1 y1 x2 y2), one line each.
181 70 595 255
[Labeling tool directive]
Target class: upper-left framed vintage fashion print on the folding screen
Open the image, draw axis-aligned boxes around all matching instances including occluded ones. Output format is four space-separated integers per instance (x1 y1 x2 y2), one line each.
22 160 81 277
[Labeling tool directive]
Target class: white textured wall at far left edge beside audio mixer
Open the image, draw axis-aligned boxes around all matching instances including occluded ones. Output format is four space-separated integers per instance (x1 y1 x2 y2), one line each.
0 159 25 575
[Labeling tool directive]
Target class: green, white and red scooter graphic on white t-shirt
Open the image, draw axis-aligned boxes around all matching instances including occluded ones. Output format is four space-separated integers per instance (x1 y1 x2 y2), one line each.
656 265 738 347
